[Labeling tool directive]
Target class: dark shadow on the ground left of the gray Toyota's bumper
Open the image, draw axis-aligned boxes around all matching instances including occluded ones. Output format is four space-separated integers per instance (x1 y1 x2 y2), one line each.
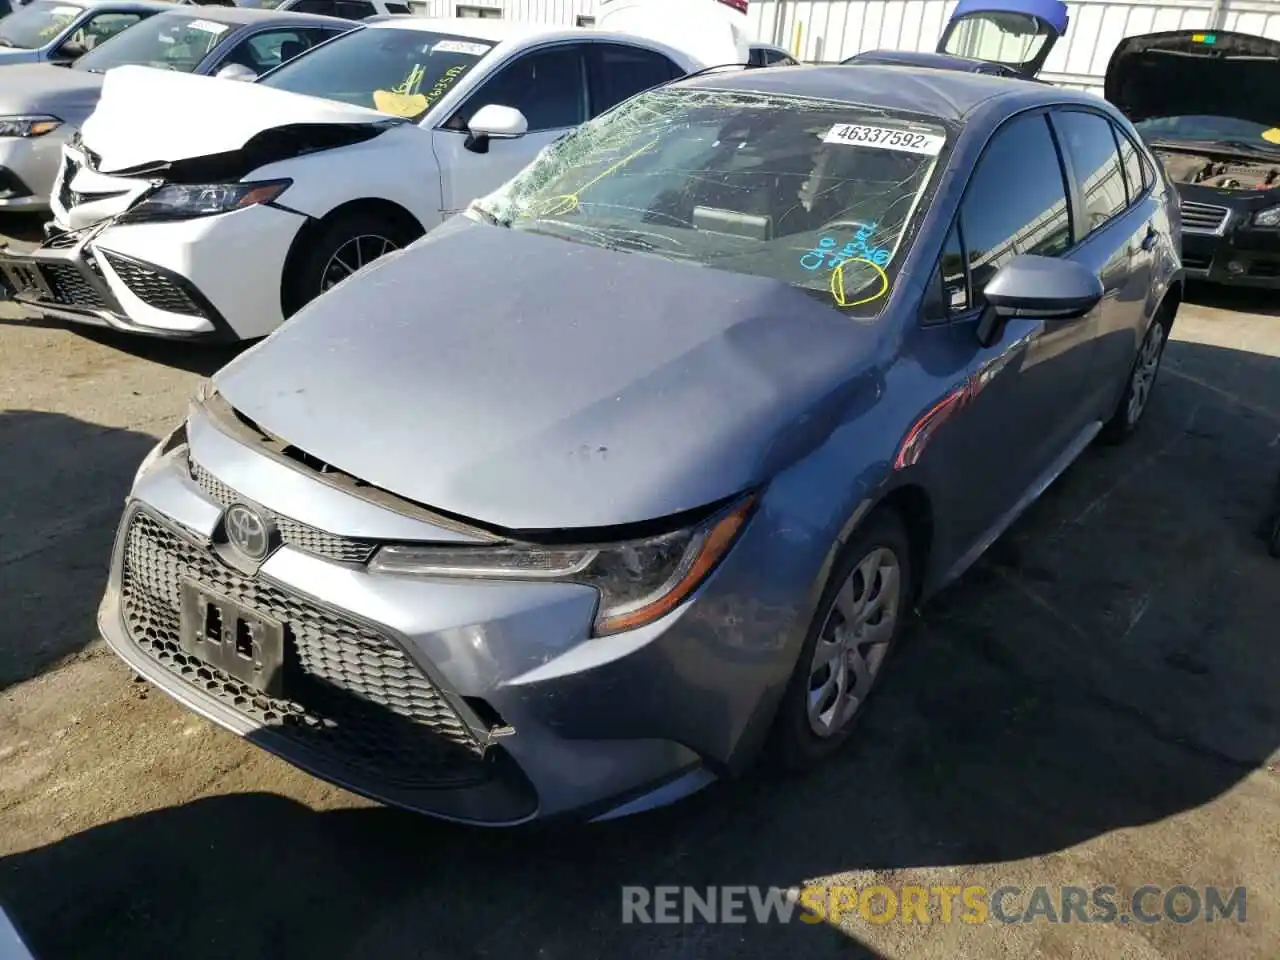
0 410 155 690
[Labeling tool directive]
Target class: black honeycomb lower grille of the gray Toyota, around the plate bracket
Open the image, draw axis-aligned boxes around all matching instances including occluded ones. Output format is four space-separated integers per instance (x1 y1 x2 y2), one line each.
120 512 489 787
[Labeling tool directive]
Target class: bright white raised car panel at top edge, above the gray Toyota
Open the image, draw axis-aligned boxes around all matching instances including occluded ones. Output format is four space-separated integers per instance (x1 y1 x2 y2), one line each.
595 0 751 67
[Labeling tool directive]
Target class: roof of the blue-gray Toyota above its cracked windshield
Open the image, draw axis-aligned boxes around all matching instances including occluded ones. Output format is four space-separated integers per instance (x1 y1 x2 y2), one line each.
673 63 1105 120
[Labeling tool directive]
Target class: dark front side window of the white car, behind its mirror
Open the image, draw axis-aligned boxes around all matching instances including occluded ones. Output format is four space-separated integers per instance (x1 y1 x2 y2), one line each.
447 46 586 133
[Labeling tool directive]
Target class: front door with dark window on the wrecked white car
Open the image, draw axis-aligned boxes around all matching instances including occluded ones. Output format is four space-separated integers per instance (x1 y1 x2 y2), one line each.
431 44 590 216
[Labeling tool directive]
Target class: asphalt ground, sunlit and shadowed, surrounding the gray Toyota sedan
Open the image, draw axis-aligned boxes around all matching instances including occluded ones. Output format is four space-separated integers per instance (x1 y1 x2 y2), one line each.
0 212 1280 960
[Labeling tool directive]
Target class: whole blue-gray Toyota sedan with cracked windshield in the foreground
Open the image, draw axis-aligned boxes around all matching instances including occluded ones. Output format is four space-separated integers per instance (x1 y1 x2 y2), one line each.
100 65 1183 824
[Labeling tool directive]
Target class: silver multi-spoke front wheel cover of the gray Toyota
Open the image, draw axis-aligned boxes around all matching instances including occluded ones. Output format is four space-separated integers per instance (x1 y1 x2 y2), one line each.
808 547 902 739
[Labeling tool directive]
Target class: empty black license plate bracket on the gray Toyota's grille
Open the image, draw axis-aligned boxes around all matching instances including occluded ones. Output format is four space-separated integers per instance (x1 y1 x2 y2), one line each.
179 581 284 698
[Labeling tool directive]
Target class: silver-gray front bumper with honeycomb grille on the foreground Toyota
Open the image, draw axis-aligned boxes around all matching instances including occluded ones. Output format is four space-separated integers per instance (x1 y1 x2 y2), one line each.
99 409 795 826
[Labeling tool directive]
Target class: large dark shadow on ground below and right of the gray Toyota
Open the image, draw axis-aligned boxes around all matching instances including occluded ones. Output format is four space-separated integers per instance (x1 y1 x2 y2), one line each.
0 342 1280 960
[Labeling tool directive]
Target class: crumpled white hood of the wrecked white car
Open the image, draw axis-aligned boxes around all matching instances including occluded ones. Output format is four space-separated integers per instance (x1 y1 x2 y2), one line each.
81 65 394 173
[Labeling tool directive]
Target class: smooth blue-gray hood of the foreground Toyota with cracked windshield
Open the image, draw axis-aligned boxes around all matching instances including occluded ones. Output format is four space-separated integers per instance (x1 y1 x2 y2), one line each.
212 216 878 531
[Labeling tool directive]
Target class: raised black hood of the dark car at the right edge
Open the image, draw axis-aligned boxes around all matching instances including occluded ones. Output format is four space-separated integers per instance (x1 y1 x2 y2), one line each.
1105 29 1280 124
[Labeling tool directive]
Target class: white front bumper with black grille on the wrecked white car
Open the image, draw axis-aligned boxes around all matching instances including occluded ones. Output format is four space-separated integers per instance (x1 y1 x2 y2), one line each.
0 200 303 340
